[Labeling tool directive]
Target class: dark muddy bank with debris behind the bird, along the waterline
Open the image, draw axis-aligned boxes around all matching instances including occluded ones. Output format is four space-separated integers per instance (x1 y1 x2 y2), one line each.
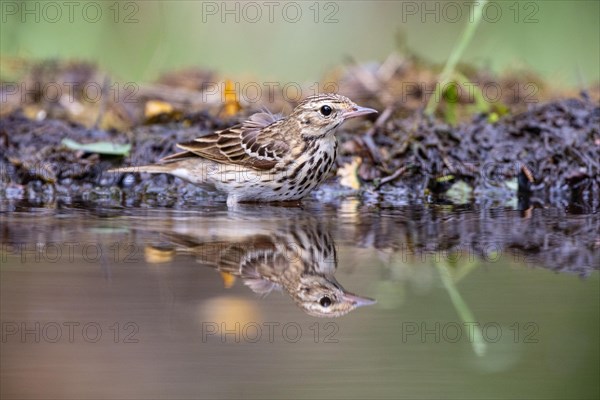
0 60 600 210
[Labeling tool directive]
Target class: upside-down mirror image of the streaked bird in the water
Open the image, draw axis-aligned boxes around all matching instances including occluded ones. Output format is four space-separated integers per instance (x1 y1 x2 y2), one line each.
163 214 375 317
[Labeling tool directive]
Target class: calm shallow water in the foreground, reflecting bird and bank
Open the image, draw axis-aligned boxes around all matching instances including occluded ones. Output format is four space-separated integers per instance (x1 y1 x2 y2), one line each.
0 200 600 399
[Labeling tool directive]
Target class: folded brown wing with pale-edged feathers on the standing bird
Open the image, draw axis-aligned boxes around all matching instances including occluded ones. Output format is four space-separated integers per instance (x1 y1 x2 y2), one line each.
161 112 290 170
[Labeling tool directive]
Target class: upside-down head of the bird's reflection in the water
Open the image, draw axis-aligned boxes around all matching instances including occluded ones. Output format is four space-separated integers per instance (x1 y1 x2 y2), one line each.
290 275 375 317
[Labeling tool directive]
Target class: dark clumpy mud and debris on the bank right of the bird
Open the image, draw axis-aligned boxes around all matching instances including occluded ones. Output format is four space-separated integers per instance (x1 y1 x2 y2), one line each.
342 98 600 209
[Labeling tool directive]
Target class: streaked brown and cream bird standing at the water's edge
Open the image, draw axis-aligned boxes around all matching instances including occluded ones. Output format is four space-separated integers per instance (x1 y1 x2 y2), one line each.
109 93 377 206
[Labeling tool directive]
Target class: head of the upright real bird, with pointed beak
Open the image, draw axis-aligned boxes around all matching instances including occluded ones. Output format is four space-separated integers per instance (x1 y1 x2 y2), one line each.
290 93 377 137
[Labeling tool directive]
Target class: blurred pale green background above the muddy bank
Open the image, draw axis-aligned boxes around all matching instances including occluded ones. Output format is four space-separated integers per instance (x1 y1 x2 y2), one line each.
0 0 600 87
